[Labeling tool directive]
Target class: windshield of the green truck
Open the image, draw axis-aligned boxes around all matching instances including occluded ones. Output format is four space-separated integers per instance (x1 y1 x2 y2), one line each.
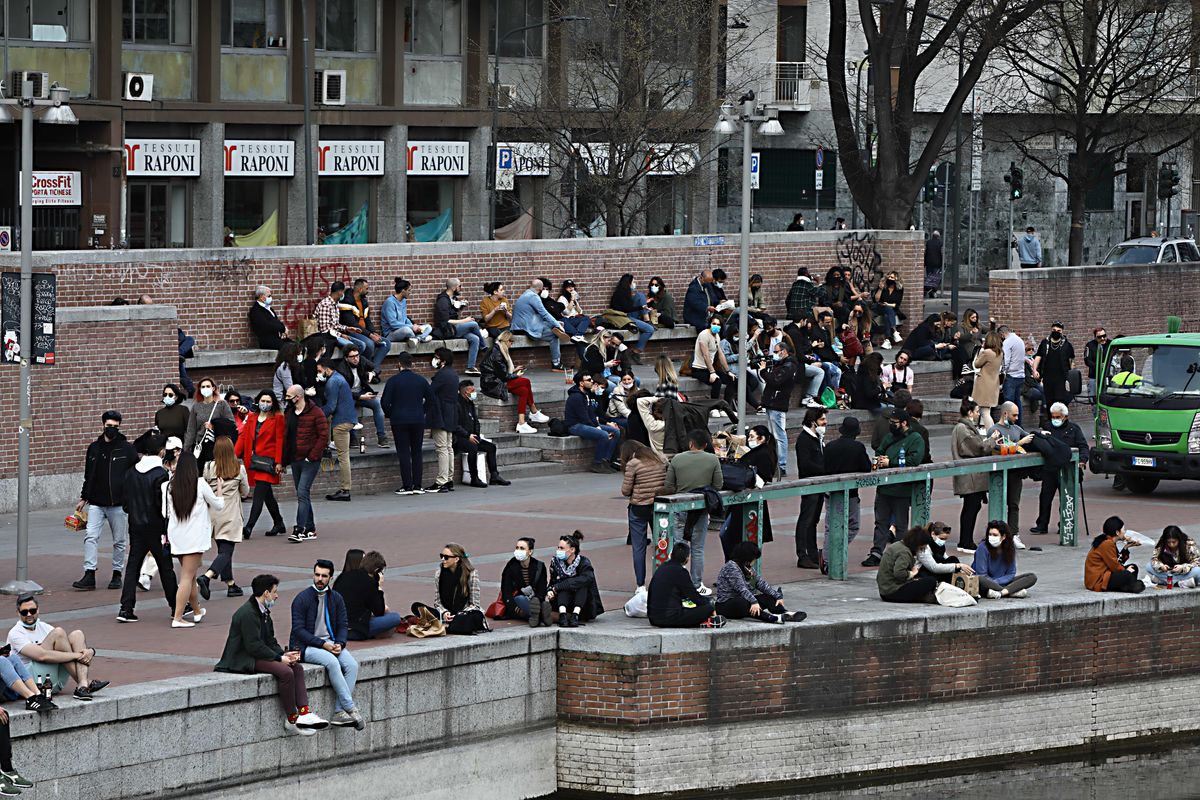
1100 342 1200 408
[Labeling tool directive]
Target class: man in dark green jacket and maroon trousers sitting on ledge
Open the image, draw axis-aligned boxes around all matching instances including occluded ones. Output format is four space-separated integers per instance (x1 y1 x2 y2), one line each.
214 575 329 736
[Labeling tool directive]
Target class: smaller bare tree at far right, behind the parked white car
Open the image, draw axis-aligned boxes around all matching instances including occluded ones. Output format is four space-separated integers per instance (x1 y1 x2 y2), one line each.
994 0 1200 264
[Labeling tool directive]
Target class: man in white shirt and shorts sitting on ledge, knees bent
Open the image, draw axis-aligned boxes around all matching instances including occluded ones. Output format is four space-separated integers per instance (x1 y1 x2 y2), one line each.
8 595 108 700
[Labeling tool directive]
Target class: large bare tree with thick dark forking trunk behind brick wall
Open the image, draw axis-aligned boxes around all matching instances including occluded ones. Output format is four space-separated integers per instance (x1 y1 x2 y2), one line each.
826 0 1051 229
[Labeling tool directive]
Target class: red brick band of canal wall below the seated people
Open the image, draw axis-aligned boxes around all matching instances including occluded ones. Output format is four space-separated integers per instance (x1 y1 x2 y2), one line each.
558 608 1200 728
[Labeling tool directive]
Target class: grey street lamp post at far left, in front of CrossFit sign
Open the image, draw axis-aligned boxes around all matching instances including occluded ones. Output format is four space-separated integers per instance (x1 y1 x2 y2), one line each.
0 80 78 595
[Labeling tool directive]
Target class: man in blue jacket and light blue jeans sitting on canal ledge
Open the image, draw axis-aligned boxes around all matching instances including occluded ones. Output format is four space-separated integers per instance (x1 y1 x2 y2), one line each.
288 559 365 730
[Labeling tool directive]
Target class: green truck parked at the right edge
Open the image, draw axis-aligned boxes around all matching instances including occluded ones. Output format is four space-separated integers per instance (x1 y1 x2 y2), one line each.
1090 333 1200 494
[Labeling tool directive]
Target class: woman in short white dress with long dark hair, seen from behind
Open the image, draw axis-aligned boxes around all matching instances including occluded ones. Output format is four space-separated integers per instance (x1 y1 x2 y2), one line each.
162 450 226 627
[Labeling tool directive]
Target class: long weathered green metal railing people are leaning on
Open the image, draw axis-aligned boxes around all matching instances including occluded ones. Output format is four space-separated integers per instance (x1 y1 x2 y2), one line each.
653 453 1079 581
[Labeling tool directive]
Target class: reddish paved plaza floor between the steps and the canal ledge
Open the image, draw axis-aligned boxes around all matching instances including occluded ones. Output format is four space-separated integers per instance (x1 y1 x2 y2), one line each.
0 424 1200 684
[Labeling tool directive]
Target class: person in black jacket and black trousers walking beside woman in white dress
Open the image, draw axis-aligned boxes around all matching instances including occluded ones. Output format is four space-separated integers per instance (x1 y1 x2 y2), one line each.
116 431 178 622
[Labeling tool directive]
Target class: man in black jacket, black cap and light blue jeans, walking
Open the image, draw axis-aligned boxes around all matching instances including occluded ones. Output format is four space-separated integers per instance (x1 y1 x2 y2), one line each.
71 410 138 591
